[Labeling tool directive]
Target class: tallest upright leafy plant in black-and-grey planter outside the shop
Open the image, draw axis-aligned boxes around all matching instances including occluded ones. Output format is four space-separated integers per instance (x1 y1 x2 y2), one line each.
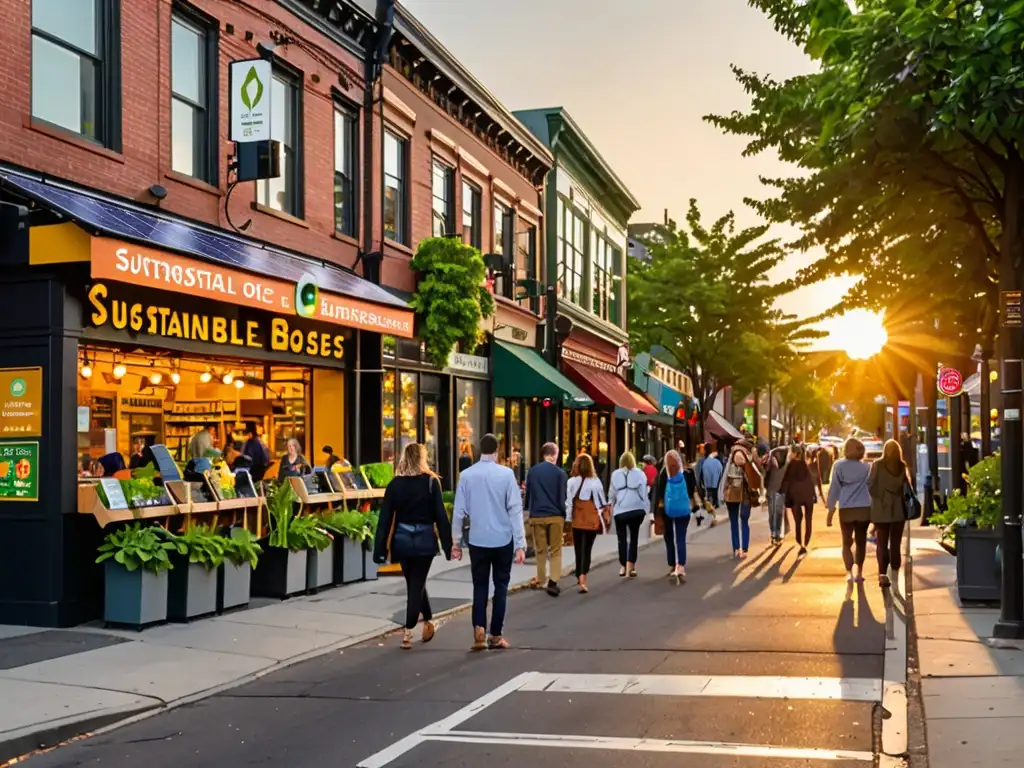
252 479 309 598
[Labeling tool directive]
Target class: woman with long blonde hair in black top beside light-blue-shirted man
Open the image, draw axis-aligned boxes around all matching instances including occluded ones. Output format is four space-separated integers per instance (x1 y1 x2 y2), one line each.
374 442 452 650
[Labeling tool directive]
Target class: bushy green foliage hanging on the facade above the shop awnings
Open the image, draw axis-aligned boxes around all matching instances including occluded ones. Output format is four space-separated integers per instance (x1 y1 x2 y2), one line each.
410 238 495 368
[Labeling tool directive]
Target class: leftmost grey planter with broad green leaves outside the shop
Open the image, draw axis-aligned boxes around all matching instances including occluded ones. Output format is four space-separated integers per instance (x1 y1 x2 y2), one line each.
96 522 177 629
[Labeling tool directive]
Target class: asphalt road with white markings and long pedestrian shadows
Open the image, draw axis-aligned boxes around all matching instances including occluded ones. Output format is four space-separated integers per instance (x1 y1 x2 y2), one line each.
25 509 885 768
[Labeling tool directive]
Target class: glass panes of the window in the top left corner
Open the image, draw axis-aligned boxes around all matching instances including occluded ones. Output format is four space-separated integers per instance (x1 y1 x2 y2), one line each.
32 0 114 148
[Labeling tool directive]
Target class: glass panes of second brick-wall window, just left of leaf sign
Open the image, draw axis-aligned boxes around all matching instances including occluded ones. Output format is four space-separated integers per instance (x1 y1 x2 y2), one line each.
171 12 218 184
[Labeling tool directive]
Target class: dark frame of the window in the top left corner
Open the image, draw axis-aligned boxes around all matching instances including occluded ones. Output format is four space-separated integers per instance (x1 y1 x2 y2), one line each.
29 0 122 153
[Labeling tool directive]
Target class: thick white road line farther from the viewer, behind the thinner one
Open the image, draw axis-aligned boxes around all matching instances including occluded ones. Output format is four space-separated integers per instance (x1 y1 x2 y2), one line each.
520 673 883 701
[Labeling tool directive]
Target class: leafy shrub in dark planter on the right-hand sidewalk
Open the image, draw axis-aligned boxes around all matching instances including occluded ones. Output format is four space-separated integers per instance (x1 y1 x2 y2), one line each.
931 454 1002 602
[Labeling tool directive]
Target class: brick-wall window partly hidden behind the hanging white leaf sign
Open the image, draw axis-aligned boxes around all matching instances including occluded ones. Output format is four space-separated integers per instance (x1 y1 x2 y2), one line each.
256 72 302 217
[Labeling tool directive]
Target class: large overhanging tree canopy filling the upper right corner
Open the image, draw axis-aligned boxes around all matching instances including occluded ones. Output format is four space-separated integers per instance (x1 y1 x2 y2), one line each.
707 0 1024 358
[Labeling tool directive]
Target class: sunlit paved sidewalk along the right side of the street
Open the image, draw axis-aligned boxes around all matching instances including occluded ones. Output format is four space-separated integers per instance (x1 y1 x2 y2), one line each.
912 526 1024 768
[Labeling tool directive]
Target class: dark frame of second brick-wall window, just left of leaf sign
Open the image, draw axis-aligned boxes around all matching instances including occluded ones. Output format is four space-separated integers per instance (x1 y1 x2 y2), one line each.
168 0 220 186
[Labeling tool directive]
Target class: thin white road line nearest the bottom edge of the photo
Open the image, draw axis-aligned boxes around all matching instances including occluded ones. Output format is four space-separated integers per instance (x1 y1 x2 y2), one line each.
423 731 874 765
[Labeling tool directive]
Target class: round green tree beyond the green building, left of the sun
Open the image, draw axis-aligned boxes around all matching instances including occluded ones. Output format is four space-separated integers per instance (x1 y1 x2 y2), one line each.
626 200 817 438
